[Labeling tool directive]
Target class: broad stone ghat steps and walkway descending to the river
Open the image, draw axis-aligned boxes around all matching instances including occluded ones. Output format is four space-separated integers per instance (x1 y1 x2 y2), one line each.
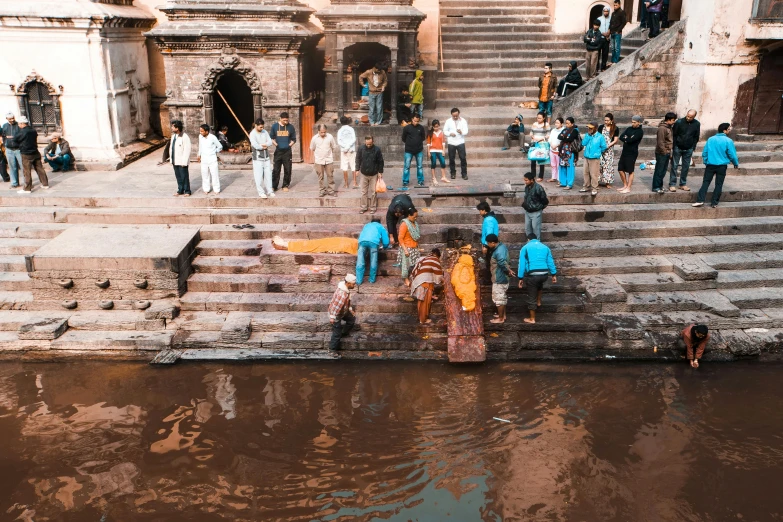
0 154 783 362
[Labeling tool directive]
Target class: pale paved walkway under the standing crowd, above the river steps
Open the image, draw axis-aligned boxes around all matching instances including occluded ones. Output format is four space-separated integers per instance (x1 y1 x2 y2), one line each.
0 153 783 206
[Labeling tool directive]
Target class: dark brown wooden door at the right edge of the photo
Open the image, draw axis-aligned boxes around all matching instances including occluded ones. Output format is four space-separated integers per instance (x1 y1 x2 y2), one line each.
750 49 783 134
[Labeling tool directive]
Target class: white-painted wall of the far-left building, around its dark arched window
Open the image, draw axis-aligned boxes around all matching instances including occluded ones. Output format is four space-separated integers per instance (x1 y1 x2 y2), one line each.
0 20 150 162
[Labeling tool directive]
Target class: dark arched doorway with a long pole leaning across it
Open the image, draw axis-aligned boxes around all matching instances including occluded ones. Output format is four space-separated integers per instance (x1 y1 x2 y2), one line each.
212 71 253 143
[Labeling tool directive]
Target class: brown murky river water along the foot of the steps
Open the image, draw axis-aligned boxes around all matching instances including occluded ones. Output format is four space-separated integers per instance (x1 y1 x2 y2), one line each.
0 362 783 522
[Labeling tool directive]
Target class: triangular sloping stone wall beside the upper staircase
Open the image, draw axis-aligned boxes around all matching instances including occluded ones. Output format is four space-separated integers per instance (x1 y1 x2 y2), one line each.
554 22 684 125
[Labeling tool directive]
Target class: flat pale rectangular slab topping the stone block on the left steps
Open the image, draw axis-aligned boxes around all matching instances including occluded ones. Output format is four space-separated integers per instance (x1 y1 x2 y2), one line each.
27 226 199 273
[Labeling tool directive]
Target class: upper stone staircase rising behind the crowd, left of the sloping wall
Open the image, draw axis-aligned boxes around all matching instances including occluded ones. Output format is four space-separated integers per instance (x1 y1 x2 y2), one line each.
438 0 584 106
